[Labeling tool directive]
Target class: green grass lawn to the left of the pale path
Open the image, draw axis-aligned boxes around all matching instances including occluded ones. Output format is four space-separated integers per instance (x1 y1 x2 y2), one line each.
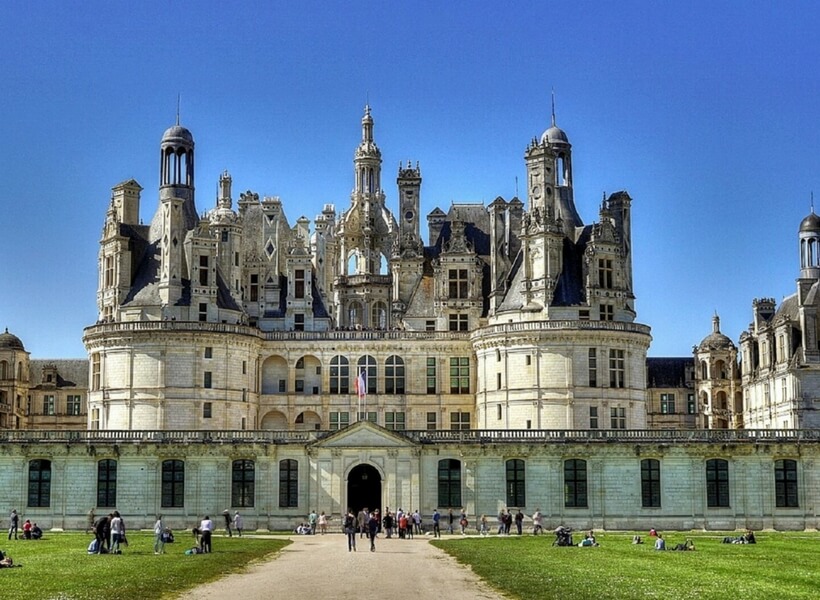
0 532 290 600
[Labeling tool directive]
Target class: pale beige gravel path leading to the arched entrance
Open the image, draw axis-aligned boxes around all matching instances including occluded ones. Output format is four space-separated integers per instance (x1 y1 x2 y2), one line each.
175 534 503 600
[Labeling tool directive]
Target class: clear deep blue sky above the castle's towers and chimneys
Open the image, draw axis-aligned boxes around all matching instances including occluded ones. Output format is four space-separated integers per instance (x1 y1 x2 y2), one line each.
0 0 820 358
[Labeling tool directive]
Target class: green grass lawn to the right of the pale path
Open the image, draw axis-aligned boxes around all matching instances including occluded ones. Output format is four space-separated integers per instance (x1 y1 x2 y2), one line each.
434 533 820 600
